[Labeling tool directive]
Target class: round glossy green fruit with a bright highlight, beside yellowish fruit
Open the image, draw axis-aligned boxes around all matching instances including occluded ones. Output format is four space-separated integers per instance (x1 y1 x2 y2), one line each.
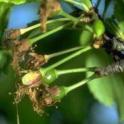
43 69 58 84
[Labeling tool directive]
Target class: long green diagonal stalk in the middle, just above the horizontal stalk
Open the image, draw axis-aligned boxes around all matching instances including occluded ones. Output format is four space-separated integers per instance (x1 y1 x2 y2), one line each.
44 46 92 72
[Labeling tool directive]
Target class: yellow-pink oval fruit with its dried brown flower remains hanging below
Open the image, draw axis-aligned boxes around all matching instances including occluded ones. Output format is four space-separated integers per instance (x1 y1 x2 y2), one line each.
15 71 45 113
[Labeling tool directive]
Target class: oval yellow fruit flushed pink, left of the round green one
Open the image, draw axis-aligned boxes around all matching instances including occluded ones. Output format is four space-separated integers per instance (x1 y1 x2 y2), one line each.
22 71 41 87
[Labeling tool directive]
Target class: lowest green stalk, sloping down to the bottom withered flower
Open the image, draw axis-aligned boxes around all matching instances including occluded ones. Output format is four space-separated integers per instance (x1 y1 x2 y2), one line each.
66 74 96 93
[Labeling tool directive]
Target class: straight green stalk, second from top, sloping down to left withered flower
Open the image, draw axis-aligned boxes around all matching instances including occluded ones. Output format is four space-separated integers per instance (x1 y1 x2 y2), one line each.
28 22 72 45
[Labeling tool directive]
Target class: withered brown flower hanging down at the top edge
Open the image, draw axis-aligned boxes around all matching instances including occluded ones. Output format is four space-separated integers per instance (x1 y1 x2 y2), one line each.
40 0 61 31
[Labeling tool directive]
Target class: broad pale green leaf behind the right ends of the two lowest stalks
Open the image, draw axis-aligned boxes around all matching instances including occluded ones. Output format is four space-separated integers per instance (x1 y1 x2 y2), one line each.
86 50 114 105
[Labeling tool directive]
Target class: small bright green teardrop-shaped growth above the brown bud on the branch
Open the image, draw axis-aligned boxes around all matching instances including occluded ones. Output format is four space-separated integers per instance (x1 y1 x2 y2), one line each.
93 19 105 38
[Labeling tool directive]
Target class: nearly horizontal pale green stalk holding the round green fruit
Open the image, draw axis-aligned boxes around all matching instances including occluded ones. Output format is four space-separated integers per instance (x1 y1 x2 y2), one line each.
56 67 95 75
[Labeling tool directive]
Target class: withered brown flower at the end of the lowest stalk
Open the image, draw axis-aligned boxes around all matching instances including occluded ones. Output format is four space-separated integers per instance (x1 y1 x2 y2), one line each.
29 86 65 114
